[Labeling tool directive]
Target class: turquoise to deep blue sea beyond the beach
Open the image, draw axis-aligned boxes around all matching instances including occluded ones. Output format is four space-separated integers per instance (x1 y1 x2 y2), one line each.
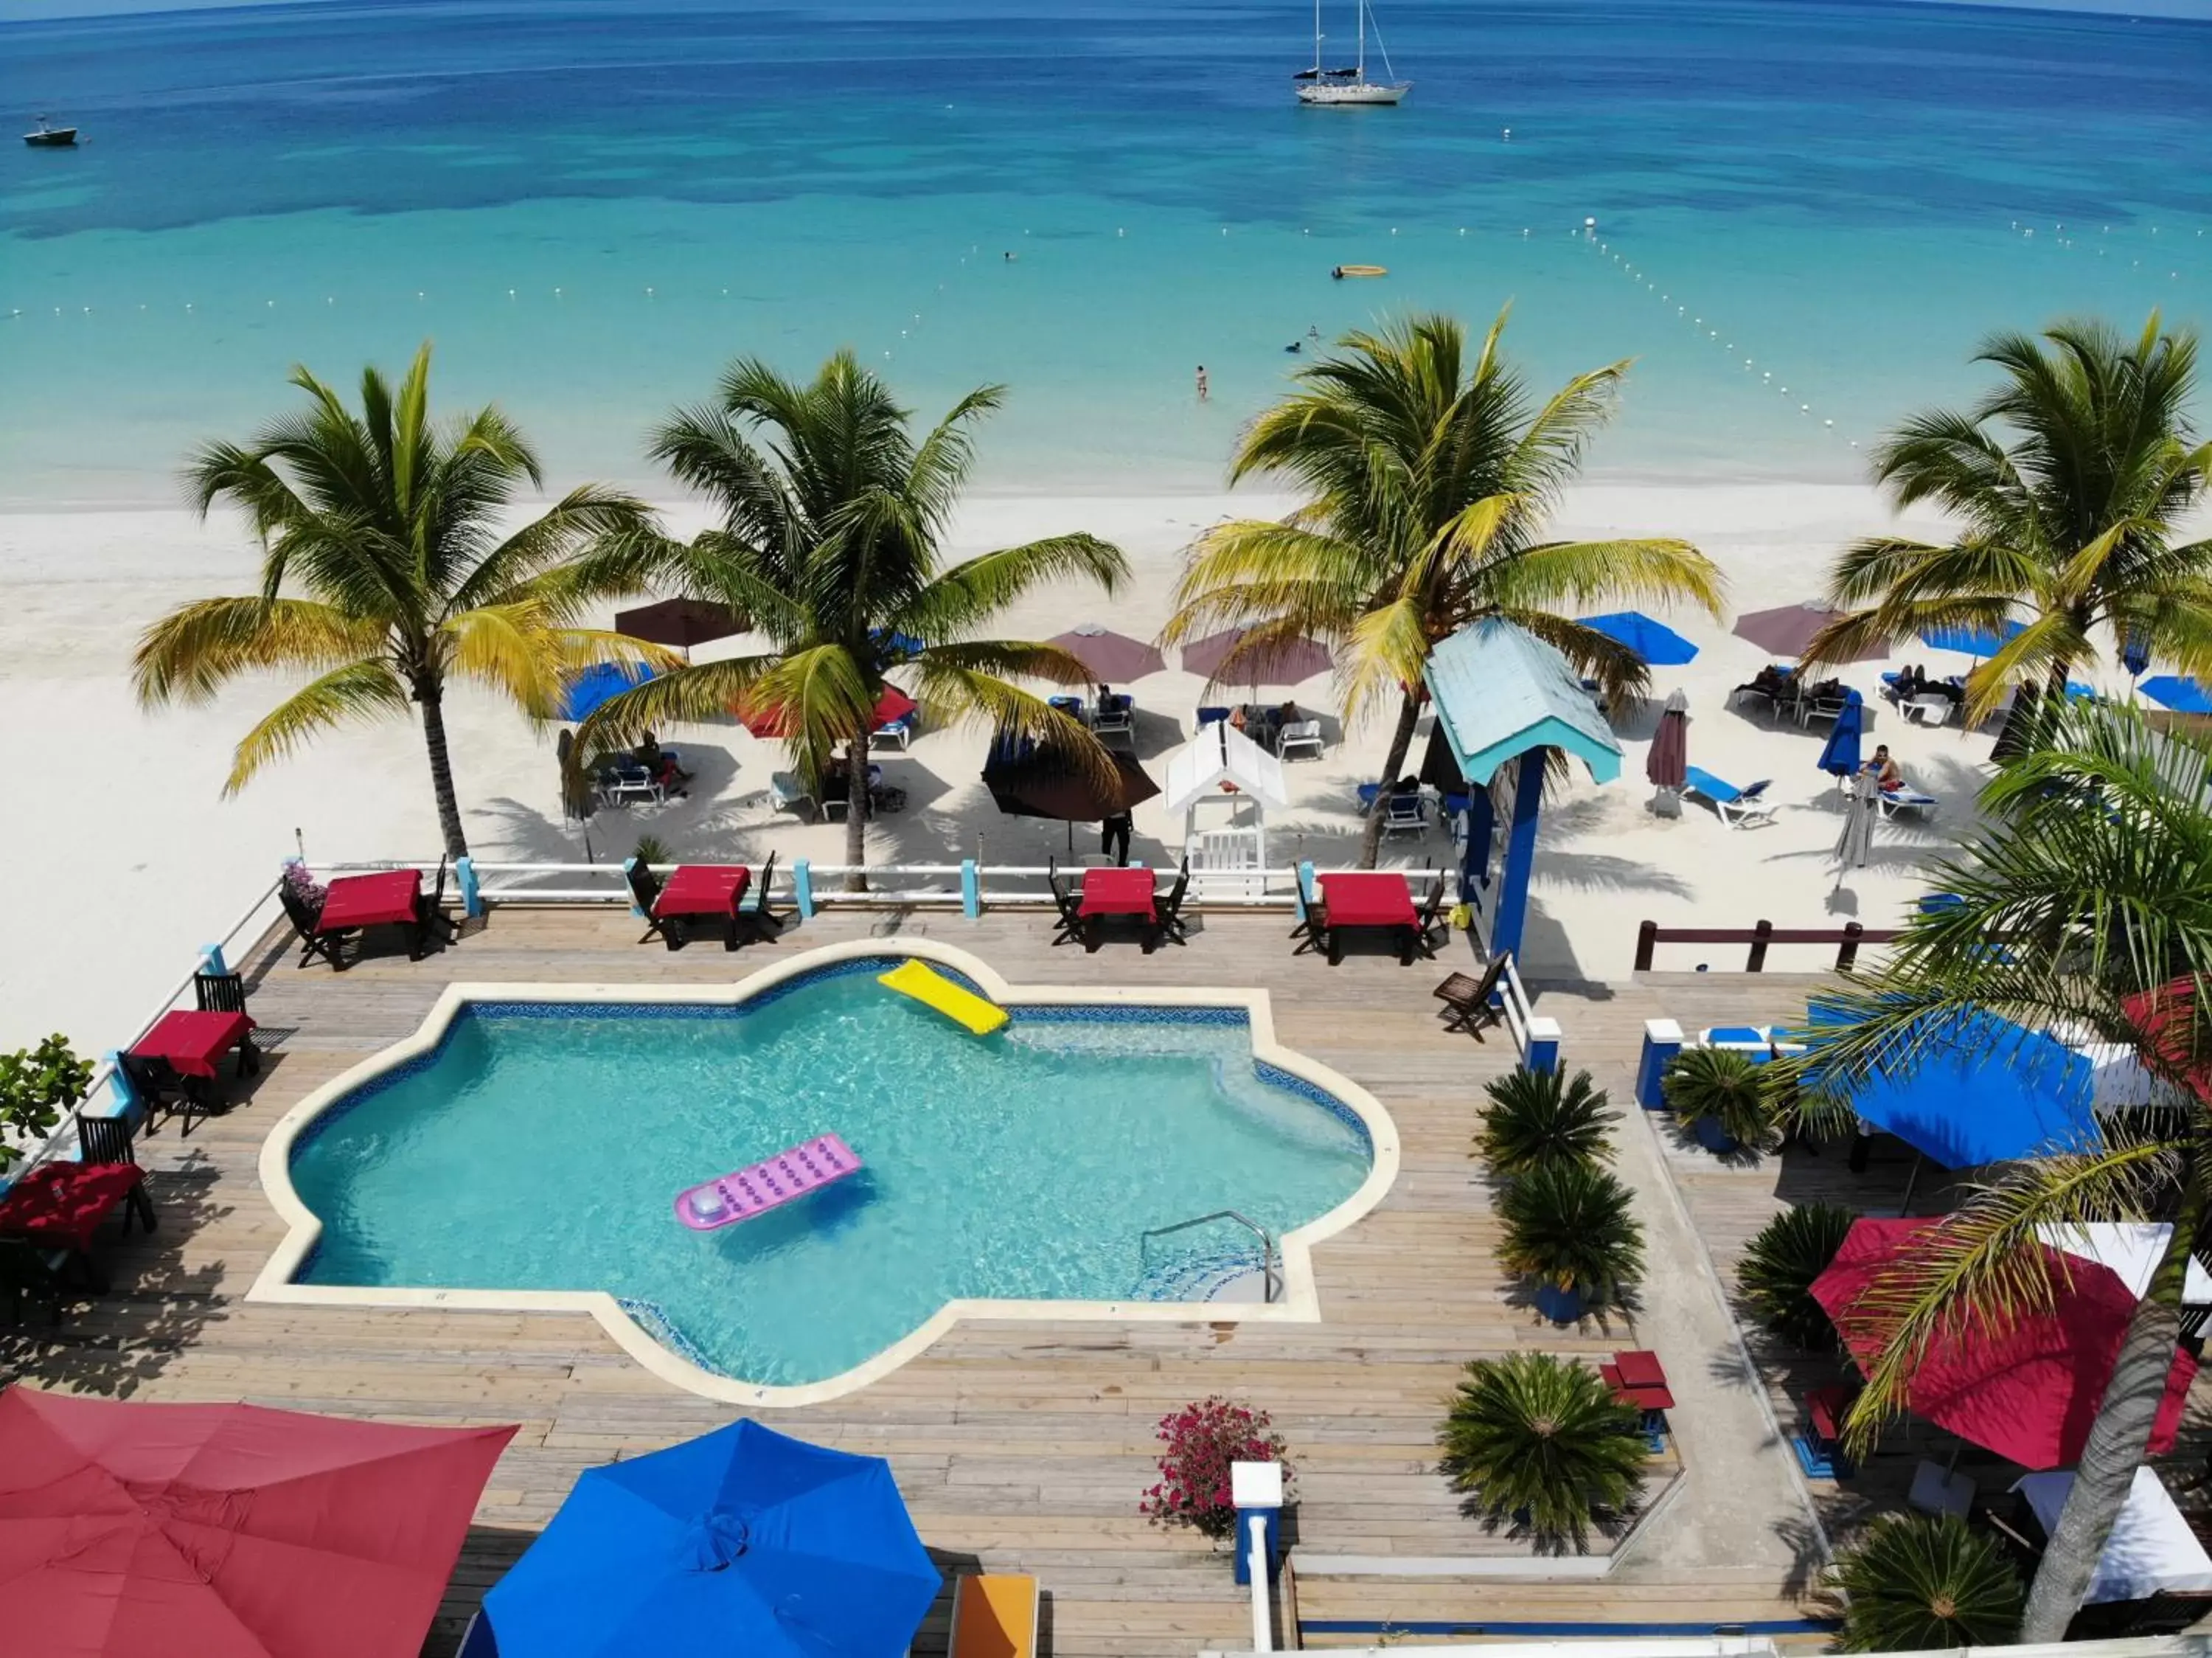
0 0 2212 504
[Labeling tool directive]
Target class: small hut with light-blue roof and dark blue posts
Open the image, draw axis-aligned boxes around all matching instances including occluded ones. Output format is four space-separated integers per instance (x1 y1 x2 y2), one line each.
1422 617 1621 954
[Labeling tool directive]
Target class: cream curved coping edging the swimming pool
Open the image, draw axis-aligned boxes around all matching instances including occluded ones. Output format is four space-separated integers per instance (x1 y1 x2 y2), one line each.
246 939 1400 1408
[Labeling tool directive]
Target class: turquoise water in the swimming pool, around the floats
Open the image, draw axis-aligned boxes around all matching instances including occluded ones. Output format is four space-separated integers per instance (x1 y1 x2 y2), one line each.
292 961 1369 1386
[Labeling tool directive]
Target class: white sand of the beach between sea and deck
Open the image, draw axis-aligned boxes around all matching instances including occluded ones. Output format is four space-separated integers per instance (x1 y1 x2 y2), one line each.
0 485 1989 1050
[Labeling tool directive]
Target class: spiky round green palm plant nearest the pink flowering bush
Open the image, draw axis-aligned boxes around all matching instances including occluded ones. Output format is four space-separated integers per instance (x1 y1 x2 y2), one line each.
1436 1353 1646 1552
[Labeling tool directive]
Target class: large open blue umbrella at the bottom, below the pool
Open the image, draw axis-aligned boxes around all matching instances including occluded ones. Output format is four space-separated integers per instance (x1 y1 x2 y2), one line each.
484 1421 940 1658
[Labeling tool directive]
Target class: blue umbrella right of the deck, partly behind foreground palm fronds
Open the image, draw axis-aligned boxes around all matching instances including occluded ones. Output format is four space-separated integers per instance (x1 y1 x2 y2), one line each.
1807 1003 2104 1169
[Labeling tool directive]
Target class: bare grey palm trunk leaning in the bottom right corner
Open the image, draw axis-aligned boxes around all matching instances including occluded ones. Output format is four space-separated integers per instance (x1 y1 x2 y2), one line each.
2020 1159 2205 1643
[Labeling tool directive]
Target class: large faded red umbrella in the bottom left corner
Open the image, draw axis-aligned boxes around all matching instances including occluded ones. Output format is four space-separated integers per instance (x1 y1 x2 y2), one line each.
0 1386 515 1658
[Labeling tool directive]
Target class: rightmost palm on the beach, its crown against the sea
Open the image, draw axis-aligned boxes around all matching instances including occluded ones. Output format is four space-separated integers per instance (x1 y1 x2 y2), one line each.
1805 312 2212 715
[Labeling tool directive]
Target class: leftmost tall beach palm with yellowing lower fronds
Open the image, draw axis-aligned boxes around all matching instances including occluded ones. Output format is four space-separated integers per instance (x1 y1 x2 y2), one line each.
133 345 675 859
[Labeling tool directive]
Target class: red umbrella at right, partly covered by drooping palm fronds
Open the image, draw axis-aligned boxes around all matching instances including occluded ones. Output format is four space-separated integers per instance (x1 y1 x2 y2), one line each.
1812 1220 2197 1468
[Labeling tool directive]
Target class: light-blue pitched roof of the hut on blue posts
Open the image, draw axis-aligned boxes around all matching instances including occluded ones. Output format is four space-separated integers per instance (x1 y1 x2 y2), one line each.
1420 617 1621 785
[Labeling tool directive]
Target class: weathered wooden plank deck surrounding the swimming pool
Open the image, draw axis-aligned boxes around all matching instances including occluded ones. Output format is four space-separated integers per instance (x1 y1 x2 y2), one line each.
0 910 1832 1658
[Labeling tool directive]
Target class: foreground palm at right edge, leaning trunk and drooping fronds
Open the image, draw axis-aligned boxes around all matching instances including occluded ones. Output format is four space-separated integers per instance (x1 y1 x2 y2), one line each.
1798 690 2212 1640
